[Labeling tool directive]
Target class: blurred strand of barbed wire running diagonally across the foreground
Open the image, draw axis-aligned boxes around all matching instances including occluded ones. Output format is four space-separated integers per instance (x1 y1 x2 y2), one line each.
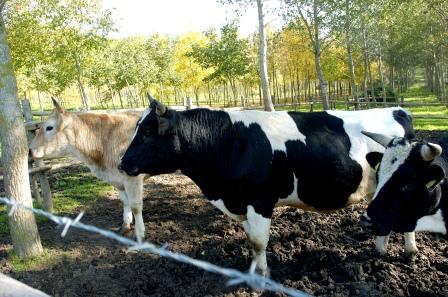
0 197 309 297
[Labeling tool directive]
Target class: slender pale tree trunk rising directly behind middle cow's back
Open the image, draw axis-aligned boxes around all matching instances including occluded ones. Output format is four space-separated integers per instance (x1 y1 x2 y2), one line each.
257 0 274 111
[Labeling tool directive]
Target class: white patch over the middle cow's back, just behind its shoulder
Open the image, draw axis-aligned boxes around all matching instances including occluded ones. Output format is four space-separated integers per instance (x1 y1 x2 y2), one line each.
228 110 306 153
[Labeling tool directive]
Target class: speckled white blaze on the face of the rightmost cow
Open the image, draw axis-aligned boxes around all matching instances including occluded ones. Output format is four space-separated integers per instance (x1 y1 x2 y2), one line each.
372 139 413 200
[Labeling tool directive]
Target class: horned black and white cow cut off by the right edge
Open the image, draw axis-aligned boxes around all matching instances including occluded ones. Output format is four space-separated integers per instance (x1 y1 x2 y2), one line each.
363 132 448 255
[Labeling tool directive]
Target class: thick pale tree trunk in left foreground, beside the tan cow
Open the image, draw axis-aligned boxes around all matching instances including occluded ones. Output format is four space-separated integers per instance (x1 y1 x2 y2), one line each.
0 12 43 258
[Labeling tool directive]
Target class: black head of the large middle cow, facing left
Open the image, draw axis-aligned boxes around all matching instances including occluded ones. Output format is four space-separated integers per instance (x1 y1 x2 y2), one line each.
119 100 180 176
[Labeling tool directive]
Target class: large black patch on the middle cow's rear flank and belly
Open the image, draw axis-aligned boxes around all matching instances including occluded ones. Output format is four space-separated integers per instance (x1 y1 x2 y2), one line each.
286 112 362 210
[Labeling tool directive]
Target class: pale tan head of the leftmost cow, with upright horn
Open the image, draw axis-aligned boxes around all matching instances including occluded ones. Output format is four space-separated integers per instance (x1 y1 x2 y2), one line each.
30 99 73 159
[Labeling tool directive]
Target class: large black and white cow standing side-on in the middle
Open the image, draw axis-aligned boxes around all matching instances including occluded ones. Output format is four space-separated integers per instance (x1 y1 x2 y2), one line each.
120 101 414 273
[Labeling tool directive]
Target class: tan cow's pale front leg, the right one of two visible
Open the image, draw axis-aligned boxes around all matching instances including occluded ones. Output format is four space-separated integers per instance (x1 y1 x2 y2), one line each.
124 176 145 242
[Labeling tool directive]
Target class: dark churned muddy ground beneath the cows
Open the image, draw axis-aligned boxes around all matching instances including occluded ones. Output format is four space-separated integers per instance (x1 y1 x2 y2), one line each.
0 132 448 297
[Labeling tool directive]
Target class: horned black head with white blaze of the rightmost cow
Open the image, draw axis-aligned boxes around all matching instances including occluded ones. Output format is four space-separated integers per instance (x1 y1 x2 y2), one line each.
363 132 445 236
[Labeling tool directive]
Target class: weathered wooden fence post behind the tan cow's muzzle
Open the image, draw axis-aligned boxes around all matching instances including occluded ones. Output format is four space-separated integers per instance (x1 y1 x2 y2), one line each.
22 99 53 212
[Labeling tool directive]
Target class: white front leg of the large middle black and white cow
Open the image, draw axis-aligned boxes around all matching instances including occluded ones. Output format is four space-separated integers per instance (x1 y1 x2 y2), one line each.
242 205 271 276
